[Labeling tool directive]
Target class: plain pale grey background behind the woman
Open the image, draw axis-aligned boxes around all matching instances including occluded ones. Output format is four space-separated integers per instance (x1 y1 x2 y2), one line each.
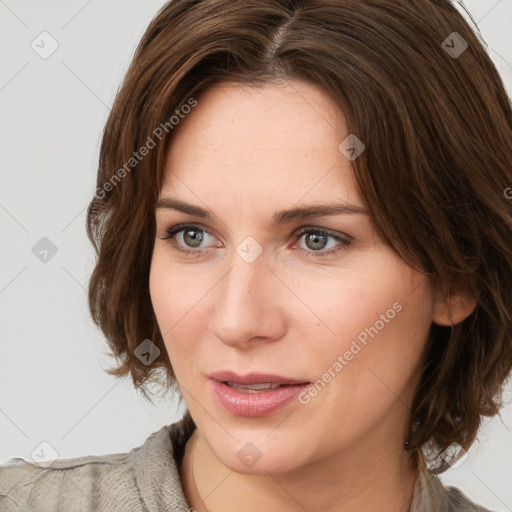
0 0 512 512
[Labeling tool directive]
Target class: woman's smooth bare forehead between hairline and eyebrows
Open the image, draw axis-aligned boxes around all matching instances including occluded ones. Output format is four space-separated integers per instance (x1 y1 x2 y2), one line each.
161 81 362 205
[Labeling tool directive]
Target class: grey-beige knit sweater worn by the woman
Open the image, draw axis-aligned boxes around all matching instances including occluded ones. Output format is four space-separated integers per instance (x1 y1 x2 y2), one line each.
0 420 496 512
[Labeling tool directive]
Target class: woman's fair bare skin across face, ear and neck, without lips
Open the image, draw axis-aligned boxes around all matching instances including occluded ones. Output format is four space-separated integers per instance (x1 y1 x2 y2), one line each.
150 80 474 512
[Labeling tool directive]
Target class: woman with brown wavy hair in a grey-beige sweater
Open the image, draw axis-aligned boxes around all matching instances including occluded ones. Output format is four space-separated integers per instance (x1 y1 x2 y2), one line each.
0 0 512 512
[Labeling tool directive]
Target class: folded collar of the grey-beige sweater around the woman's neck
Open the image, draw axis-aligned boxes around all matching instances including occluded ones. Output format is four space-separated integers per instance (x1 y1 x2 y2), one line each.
130 420 449 512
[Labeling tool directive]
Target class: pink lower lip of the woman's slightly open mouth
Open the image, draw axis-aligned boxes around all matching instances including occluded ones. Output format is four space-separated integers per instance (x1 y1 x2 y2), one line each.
210 379 309 417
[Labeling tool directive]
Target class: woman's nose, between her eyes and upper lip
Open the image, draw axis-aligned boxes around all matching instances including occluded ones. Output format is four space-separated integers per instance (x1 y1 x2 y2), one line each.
209 251 286 348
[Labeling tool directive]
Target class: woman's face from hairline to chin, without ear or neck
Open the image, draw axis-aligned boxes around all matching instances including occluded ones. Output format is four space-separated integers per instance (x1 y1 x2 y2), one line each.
150 81 434 473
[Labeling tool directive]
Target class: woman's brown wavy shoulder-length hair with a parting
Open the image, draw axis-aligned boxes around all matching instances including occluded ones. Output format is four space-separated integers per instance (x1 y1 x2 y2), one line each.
87 0 512 473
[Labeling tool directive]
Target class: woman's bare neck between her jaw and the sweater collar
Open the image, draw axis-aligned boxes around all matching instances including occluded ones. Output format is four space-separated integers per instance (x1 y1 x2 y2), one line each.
180 429 417 512
